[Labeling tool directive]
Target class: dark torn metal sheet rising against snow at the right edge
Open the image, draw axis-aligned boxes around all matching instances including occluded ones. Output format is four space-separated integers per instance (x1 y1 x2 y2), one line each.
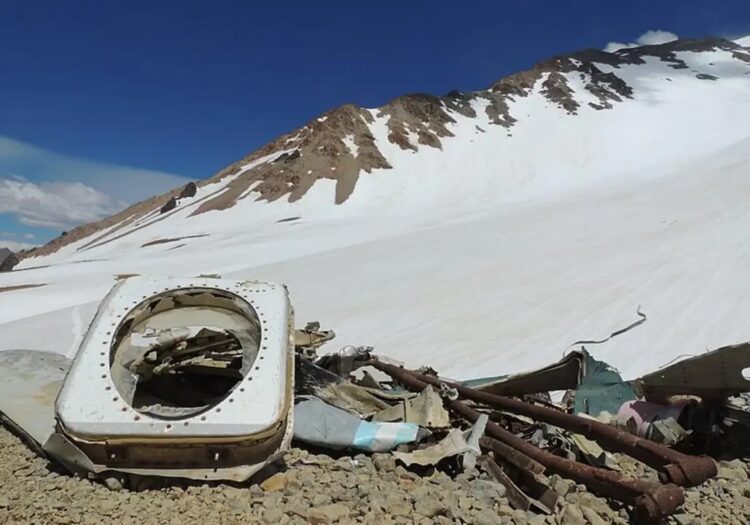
636 343 750 403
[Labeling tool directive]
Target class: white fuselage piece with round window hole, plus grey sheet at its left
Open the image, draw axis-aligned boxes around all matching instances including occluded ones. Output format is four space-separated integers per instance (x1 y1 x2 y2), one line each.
0 276 294 481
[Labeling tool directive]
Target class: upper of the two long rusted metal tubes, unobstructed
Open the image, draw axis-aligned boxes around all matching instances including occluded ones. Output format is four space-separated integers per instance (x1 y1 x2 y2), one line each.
400 362 718 487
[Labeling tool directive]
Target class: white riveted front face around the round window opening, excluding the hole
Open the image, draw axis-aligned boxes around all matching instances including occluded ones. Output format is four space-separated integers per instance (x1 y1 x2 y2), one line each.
57 277 292 439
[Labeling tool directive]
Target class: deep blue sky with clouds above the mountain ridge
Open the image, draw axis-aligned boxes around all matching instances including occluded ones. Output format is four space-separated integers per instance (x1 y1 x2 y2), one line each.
0 0 750 245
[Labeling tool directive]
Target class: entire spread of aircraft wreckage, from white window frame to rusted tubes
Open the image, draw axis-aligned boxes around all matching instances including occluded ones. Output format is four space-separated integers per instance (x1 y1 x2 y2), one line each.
0 276 750 521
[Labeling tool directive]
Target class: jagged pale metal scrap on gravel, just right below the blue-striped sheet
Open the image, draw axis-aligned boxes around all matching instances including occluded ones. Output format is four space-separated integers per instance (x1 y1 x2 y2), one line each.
393 414 488 471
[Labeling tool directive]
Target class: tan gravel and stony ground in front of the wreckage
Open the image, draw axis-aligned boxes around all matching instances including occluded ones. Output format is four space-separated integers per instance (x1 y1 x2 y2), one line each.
0 428 750 525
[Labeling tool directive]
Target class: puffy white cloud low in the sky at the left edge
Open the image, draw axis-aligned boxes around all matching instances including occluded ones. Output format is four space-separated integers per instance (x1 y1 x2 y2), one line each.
0 179 124 229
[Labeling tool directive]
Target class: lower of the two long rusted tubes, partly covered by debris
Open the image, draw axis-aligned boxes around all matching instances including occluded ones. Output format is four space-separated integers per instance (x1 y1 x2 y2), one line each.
371 361 684 521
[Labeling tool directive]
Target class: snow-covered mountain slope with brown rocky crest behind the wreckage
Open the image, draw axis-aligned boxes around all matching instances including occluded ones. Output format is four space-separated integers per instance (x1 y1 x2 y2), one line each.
0 38 750 377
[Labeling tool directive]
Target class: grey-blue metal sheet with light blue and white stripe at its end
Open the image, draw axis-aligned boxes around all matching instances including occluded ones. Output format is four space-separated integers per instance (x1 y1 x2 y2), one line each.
294 397 423 452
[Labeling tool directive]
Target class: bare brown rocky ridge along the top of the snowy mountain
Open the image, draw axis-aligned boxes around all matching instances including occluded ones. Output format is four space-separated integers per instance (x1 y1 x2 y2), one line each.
23 33 750 257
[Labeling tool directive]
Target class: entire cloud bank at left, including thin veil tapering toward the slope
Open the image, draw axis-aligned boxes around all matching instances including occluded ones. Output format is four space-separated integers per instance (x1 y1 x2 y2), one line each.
0 135 188 229
